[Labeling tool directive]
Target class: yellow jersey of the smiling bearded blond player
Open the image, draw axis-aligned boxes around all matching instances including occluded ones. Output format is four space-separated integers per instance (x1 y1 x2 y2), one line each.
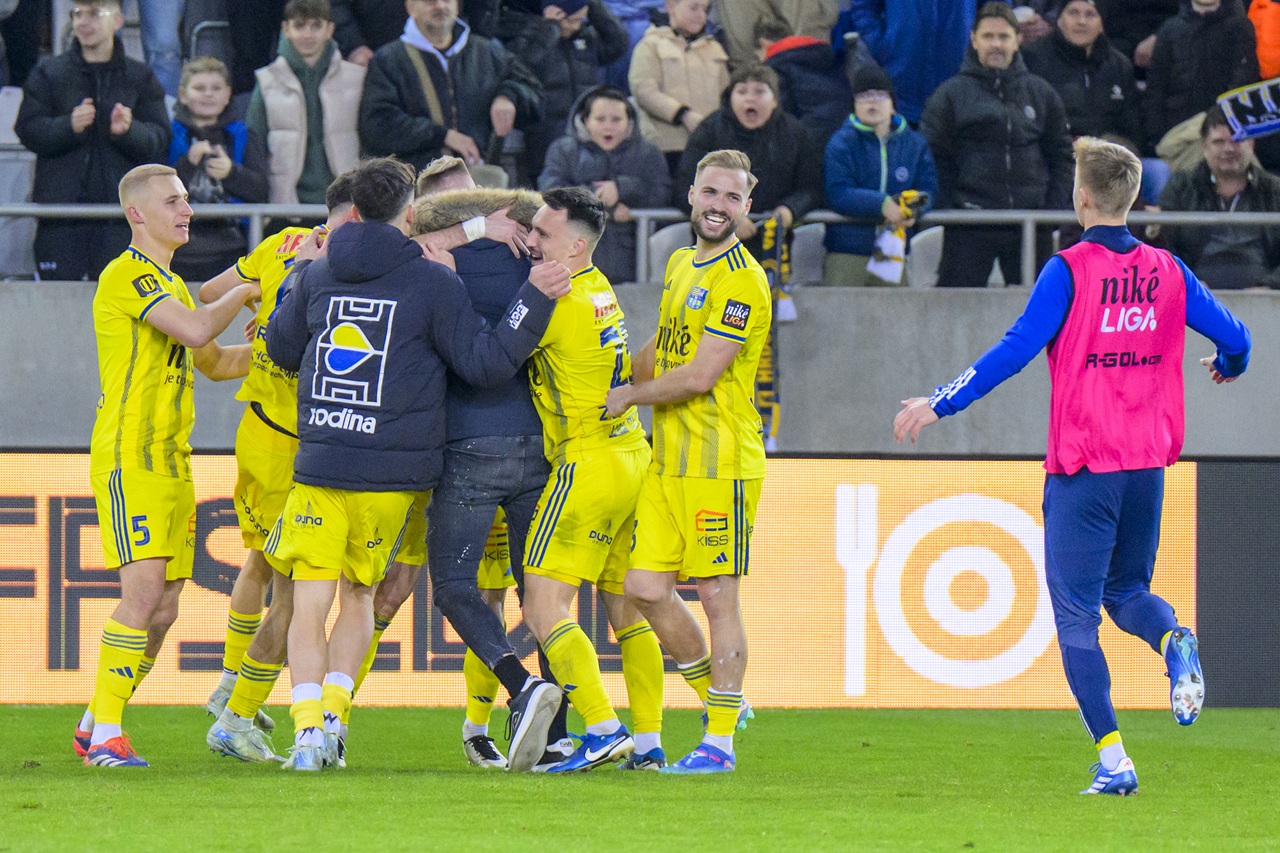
655 242 773 480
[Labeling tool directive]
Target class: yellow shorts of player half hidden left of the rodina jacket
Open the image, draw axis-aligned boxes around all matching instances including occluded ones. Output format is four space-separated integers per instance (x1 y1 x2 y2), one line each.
236 407 298 551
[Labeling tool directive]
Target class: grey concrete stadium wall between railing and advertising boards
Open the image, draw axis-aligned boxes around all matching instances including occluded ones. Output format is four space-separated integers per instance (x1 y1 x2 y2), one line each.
0 282 1280 456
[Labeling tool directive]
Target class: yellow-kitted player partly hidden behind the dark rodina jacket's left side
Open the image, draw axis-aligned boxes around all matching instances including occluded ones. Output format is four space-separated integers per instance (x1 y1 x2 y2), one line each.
200 175 352 761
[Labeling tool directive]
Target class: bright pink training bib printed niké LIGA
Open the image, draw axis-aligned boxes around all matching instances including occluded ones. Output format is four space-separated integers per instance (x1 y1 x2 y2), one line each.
1044 242 1187 474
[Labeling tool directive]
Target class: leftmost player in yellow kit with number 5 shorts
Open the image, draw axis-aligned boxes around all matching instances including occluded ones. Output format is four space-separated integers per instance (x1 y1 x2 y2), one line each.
74 164 259 767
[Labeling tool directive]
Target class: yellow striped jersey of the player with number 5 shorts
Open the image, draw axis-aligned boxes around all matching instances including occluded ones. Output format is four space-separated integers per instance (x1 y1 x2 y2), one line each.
90 246 196 480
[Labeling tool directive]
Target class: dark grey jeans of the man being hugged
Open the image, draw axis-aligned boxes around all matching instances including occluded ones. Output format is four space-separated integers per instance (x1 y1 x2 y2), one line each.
428 435 550 669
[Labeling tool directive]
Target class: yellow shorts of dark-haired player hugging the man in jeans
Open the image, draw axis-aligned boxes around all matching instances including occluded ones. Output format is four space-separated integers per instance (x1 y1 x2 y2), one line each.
525 446 652 596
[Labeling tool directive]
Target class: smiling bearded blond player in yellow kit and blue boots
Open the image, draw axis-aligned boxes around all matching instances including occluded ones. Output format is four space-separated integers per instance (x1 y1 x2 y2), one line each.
607 151 772 774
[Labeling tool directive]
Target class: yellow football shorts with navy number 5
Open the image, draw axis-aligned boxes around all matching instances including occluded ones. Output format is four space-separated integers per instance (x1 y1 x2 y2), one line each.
90 469 196 580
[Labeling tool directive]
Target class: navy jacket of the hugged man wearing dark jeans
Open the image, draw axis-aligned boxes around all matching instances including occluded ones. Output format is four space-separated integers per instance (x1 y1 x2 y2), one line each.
444 240 543 442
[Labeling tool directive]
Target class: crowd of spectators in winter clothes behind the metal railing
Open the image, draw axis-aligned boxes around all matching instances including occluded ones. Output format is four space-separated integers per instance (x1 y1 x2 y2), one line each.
0 0 1280 288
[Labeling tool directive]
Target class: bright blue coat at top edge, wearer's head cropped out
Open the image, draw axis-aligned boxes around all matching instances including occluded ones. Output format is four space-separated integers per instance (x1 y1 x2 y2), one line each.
832 0 1008 124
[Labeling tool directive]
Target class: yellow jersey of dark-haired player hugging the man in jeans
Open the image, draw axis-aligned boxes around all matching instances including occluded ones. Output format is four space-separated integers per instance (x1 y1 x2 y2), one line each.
529 266 645 465
